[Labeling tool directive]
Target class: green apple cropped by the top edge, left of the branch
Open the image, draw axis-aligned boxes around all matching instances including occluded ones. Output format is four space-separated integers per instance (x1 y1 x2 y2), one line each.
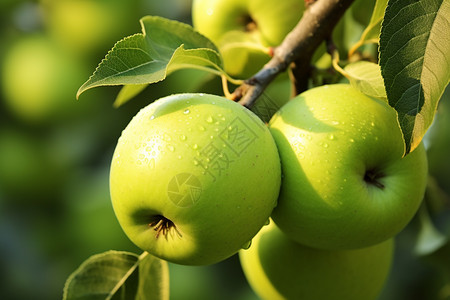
192 0 305 78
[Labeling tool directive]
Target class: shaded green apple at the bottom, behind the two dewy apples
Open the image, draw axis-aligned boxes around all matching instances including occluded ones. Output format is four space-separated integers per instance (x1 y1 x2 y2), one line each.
239 222 394 300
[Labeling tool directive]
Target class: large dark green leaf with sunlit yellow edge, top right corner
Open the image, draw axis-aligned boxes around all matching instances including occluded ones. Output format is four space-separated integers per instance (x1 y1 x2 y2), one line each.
380 0 450 154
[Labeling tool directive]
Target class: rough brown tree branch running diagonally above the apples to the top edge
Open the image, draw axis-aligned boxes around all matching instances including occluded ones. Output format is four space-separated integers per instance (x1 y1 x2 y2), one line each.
233 0 353 108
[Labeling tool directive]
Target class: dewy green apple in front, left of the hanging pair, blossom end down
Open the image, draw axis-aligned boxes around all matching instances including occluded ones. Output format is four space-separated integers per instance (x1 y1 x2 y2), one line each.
110 94 281 265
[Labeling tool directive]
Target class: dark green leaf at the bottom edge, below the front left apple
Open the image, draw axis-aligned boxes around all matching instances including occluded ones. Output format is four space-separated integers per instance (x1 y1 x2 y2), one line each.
63 251 169 300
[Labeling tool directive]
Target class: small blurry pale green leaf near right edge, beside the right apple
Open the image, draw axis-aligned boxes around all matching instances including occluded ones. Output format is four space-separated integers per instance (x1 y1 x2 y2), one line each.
414 205 448 256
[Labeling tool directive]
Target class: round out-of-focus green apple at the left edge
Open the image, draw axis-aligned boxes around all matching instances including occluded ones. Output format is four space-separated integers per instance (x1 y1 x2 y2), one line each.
1 35 89 123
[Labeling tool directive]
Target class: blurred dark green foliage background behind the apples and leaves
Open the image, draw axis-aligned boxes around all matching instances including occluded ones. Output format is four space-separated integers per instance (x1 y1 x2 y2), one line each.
0 0 450 300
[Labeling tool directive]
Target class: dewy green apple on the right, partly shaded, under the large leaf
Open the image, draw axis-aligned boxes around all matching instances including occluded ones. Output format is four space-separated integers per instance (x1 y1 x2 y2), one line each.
269 84 428 249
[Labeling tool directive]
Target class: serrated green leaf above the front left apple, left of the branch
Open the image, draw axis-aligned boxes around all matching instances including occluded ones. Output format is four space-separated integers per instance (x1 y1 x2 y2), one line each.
77 16 225 103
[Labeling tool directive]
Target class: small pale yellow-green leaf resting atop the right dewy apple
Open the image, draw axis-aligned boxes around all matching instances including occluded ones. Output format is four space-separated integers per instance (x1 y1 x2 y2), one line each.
344 61 387 101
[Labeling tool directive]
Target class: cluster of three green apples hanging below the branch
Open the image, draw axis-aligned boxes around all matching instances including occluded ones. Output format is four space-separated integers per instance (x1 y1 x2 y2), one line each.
110 0 427 300
